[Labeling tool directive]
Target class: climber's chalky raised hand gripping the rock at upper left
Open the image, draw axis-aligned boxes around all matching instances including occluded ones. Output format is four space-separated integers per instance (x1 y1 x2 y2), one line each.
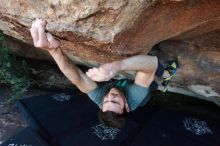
30 19 60 51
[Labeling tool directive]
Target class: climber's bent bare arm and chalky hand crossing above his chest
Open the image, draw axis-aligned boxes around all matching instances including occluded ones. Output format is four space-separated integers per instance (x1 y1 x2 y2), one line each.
87 55 158 82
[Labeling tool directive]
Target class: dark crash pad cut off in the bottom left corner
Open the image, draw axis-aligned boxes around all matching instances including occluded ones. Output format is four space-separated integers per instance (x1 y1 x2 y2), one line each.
1 128 49 146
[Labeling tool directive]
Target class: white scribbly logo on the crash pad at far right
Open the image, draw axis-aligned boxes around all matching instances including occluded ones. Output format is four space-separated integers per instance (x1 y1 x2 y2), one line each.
183 117 213 135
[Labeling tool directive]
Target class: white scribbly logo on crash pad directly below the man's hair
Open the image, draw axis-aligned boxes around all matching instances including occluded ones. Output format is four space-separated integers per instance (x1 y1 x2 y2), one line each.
92 124 120 140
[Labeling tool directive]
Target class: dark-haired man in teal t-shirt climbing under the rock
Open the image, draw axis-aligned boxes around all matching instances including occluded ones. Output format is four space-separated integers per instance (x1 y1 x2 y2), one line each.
30 19 176 127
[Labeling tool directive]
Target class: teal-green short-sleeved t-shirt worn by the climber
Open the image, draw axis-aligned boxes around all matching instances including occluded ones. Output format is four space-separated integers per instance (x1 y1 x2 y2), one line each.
88 80 150 111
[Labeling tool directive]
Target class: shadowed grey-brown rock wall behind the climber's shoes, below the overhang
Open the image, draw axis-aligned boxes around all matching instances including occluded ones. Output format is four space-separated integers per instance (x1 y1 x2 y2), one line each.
156 30 220 105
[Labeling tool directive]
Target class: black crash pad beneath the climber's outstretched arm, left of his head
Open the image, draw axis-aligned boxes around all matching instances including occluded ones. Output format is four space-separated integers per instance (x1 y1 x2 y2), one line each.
17 90 99 140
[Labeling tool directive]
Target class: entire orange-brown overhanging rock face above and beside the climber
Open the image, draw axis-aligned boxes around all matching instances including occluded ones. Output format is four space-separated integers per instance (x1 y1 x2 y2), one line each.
0 0 220 104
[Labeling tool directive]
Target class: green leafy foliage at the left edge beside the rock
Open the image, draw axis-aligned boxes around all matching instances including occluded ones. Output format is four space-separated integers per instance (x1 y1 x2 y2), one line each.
0 33 31 103
